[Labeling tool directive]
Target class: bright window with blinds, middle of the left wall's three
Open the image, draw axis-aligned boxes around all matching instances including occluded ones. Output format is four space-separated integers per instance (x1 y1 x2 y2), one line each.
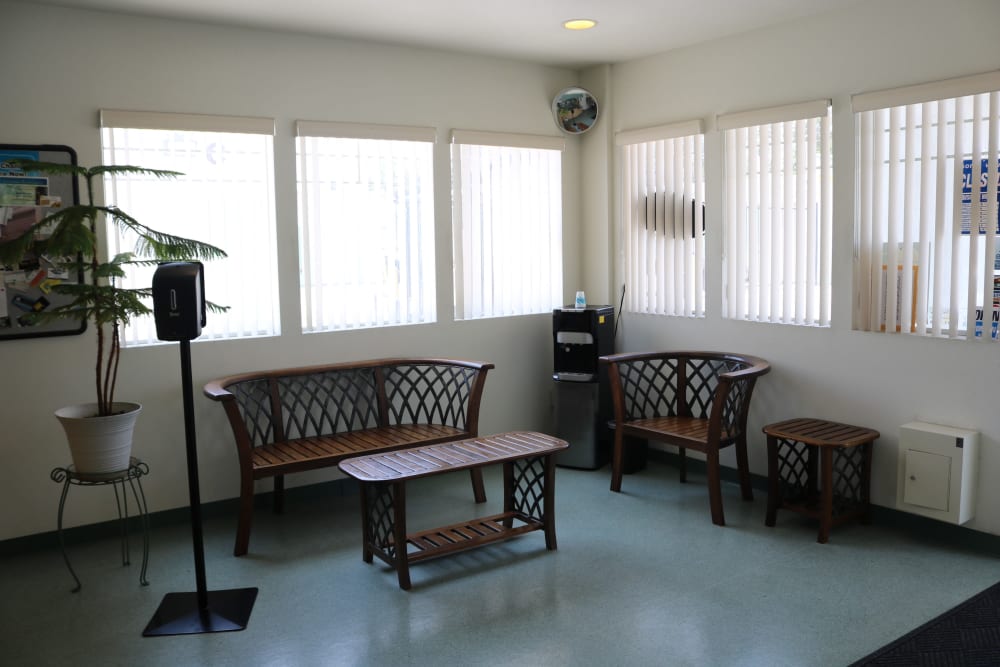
296 121 436 332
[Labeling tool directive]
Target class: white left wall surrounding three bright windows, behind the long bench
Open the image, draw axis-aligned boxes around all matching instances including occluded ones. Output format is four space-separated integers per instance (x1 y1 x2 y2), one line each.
0 1 581 539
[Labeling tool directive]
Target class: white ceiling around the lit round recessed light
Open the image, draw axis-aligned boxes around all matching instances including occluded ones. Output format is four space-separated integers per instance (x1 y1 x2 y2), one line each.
29 0 859 69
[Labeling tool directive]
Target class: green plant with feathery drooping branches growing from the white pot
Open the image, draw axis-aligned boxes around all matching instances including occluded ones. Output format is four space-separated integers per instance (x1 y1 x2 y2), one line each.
0 160 226 417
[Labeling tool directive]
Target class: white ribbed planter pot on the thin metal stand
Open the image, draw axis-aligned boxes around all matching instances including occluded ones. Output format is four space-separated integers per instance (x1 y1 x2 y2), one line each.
56 401 142 473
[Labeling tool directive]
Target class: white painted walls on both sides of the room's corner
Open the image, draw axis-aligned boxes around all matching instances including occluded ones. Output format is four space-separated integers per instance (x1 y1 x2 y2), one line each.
0 0 1000 539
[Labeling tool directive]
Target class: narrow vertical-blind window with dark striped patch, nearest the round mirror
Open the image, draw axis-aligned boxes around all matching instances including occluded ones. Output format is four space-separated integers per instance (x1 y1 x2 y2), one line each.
615 121 705 317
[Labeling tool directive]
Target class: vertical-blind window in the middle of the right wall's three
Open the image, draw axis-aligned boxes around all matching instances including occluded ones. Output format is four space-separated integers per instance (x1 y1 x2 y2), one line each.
718 100 833 326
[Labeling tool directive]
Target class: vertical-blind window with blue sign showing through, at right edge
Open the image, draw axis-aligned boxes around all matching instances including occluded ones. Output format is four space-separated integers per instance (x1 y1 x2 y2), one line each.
851 71 1000 341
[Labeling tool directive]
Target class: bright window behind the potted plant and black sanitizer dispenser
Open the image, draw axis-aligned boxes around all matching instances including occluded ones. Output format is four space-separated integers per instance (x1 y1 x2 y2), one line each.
99 109 281 347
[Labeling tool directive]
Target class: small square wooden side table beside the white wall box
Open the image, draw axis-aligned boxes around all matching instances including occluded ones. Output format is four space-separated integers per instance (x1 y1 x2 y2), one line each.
764 419 879 544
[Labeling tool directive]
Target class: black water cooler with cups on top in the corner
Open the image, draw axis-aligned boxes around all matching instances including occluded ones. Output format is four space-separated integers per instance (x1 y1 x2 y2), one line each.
552 306 615 470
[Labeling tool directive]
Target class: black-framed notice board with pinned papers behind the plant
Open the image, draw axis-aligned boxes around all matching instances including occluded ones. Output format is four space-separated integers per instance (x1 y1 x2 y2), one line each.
0 144 87 340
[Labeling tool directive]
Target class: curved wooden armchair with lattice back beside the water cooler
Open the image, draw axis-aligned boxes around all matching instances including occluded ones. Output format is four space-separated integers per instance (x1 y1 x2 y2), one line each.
600 352 771 526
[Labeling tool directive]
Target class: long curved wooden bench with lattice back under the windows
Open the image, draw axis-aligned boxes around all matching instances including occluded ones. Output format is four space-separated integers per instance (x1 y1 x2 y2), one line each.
205 358 493 556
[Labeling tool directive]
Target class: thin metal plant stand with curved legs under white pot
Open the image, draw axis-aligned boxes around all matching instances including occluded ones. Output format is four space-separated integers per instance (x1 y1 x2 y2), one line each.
50 457 149 593
